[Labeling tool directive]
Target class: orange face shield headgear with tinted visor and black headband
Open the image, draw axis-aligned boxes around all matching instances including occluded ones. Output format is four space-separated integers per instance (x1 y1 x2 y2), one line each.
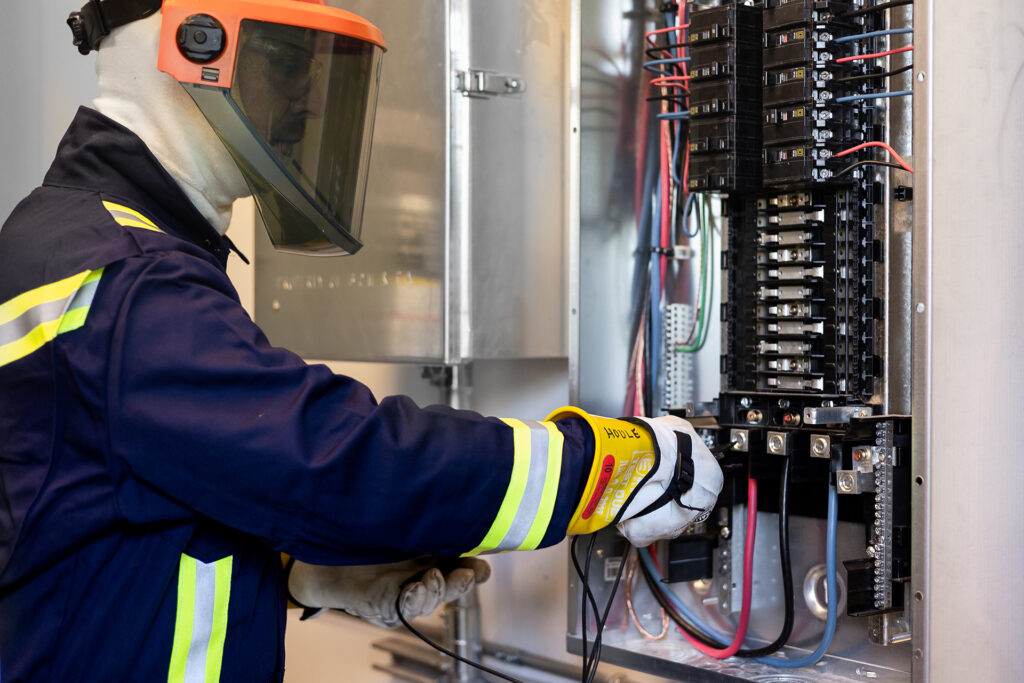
69 0 386 256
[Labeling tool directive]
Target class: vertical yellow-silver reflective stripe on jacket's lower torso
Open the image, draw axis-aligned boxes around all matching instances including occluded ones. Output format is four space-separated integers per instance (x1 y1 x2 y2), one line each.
167 553 233 683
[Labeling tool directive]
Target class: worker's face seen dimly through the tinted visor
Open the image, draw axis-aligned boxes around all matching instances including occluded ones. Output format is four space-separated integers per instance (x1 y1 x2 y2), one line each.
237 30 324 156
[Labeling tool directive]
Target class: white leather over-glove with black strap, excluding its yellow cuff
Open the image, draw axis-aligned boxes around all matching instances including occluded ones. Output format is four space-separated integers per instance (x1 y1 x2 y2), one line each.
617 416 723 548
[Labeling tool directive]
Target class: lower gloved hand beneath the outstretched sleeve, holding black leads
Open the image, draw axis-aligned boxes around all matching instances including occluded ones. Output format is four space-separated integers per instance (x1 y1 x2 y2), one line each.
287 556 490 629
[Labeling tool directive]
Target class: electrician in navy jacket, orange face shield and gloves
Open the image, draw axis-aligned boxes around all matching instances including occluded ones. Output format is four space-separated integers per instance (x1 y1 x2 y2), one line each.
0 0 722 683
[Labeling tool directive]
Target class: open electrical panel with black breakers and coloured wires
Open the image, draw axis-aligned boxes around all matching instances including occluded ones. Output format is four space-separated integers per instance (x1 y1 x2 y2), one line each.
568 0 913 682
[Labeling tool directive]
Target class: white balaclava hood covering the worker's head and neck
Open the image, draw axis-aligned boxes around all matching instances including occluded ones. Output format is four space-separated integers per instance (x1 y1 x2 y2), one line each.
92 12 251 234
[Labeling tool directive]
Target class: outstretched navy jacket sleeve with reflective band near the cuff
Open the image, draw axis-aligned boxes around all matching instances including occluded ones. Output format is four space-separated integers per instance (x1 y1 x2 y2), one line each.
106 253 594 563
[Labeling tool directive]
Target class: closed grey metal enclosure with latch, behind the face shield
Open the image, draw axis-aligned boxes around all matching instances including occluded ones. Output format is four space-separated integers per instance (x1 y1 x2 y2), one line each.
248 0 569 364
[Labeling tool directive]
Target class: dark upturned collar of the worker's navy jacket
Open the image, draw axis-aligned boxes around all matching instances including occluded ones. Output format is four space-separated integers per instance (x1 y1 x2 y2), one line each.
43 106 235 266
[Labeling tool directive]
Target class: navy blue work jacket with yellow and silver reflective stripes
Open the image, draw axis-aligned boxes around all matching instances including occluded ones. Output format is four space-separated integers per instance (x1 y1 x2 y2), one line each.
0 109 593 683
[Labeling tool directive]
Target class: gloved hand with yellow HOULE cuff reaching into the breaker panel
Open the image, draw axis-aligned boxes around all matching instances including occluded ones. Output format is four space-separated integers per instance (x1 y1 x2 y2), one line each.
548 408 723 546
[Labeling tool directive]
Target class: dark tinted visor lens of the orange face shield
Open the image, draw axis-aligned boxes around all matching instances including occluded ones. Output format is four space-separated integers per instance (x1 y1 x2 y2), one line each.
230 20 381 253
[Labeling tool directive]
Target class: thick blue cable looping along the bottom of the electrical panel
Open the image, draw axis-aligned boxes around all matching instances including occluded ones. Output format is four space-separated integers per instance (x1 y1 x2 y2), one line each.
637 486 839 669
